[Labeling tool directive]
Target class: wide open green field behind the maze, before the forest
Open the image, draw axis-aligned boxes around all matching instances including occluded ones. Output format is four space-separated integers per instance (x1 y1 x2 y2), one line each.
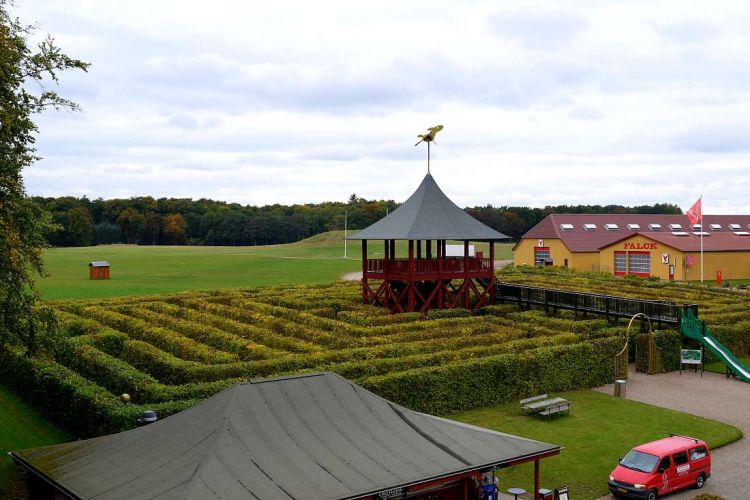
37 231 513 300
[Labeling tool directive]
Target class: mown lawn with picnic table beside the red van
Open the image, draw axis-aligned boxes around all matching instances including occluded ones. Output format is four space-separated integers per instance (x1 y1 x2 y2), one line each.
449 390 742 499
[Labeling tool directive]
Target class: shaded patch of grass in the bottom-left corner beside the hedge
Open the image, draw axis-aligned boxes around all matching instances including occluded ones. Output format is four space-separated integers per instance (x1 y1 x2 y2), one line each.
0 386 71 499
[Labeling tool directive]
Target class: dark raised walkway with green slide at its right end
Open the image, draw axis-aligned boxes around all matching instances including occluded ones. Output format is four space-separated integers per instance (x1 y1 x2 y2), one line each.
495 283 750 383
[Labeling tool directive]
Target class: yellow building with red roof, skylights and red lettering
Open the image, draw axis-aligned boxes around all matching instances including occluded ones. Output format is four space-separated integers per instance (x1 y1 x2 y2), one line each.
513 214 750 281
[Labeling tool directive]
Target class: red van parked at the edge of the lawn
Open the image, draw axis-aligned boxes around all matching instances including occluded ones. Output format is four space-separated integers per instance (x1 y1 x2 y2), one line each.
609 436 711 500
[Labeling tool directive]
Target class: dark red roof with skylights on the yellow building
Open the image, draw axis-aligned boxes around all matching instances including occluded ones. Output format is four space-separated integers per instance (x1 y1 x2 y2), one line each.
522 214 750 252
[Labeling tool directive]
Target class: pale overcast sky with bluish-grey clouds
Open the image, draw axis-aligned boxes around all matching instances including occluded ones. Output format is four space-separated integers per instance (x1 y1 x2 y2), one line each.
13 0 750 214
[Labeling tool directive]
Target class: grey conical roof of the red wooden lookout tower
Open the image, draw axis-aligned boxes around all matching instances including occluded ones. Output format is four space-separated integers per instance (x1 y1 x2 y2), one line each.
347 174 510 241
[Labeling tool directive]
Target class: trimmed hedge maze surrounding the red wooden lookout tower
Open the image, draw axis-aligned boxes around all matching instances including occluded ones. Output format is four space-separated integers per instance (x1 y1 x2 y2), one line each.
0 269 750 436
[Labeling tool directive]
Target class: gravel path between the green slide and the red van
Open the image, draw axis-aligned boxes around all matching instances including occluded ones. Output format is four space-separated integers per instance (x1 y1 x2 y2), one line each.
596 365 750 500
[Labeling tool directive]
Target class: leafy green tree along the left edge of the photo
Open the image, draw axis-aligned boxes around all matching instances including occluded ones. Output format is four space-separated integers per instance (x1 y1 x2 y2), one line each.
0 0 88 354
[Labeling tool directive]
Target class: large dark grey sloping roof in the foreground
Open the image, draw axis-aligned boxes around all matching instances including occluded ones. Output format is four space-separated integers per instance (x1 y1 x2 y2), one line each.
13 373 559 500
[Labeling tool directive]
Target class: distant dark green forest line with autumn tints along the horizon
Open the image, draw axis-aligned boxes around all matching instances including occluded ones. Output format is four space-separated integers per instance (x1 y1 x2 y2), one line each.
33 194 681 246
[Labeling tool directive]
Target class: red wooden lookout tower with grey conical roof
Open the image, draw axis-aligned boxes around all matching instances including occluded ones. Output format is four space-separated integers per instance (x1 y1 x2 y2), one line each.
347 172 509 313
